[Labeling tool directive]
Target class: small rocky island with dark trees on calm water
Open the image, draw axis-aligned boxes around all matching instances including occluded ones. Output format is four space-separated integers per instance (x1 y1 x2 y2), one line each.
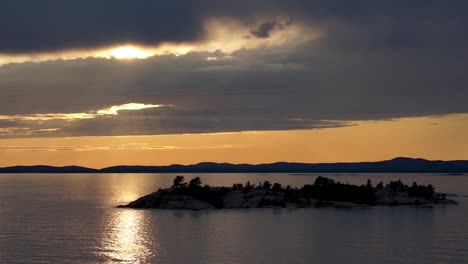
118 176 457 210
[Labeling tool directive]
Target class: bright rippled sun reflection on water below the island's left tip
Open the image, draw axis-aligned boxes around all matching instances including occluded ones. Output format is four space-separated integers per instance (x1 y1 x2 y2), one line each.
102 209 158 263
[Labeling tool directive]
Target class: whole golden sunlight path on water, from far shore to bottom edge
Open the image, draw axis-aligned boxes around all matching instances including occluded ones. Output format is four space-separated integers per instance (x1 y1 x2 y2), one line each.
98 174 169 263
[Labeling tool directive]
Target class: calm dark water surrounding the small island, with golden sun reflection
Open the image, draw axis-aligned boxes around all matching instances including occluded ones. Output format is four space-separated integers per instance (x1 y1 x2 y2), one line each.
0 174 468 264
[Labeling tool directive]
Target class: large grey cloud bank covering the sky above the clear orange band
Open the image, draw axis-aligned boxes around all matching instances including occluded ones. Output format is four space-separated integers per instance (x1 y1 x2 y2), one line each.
0 0 468 137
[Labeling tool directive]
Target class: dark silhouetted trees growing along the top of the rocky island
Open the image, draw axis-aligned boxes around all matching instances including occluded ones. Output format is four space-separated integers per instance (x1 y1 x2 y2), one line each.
159 176 435 208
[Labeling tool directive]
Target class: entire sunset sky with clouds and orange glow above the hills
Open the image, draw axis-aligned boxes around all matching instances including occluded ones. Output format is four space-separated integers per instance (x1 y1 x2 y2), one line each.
0 0 468 167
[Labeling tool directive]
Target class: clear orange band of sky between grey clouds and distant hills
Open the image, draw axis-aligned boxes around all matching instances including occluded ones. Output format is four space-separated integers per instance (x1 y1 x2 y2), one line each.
0 115 468 168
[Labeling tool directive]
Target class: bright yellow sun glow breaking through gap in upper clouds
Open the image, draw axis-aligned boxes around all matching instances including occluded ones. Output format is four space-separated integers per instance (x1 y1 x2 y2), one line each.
0 18 322 65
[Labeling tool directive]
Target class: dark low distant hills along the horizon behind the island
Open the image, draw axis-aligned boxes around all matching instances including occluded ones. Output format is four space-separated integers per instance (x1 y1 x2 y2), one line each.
0 157 468 173
